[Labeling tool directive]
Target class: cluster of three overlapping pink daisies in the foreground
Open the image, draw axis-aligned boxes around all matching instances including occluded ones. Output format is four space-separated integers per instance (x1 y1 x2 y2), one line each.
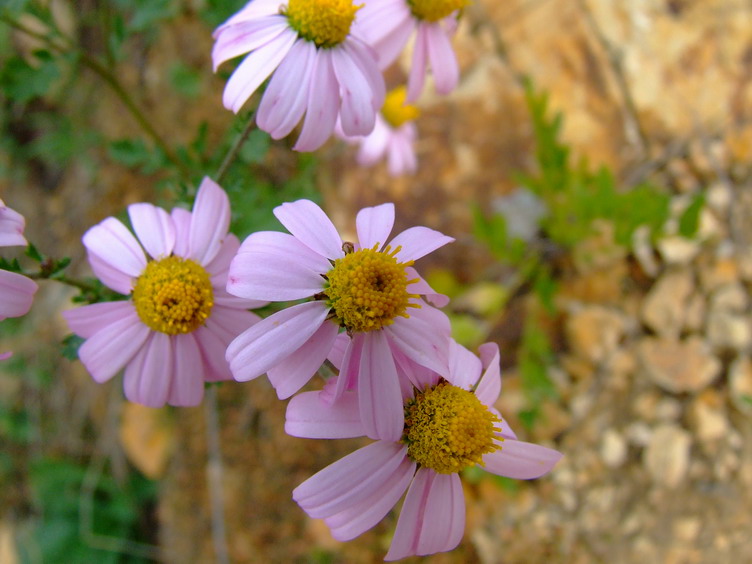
55 178 561 560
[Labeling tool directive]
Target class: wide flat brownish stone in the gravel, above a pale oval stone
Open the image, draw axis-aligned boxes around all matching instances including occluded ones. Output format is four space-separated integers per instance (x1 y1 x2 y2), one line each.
637 336 721 394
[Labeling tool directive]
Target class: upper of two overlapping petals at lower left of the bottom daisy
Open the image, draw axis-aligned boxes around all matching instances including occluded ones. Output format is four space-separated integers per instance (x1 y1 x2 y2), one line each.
292 441 415 519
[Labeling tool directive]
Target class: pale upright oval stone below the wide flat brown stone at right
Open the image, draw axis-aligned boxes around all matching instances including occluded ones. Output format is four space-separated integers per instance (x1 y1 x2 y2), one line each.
643 425 692 488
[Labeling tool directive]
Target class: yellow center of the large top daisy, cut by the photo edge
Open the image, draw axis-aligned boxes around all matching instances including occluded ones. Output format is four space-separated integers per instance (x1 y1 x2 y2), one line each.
282 0 362 47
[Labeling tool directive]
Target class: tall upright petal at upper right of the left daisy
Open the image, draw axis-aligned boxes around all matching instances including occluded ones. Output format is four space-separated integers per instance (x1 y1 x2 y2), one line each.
188 176 230 265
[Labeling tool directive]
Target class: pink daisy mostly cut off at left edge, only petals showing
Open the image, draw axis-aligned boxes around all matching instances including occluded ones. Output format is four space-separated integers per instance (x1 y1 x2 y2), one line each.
0 200 38 321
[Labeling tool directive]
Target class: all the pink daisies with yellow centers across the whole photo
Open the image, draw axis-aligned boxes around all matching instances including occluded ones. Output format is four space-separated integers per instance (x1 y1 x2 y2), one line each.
0 0 561 560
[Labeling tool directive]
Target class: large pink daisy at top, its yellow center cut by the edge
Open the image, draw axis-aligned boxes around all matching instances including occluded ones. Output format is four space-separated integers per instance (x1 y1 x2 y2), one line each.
212 0 385 151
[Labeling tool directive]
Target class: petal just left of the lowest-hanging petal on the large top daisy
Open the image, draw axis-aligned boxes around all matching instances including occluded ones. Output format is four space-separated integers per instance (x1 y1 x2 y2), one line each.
256 37 316 139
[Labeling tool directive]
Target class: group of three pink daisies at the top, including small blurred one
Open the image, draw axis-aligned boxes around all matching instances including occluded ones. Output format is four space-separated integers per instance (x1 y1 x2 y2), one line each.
212 0 468 175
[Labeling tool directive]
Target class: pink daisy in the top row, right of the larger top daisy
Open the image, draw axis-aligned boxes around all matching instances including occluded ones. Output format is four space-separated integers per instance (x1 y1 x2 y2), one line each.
356 0 469 102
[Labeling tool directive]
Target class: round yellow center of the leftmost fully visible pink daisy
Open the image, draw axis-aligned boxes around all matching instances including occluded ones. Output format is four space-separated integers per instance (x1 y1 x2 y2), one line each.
133 256 214 335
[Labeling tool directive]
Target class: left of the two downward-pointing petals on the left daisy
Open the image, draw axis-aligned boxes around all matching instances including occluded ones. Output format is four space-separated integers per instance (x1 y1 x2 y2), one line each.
123 332 174 407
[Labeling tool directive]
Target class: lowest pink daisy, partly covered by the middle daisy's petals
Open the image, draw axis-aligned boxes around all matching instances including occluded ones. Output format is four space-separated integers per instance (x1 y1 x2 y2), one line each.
285 341 561 560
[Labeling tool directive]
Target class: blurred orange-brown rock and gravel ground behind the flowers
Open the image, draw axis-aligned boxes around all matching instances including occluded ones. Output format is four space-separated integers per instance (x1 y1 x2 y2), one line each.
0 0 752 564
